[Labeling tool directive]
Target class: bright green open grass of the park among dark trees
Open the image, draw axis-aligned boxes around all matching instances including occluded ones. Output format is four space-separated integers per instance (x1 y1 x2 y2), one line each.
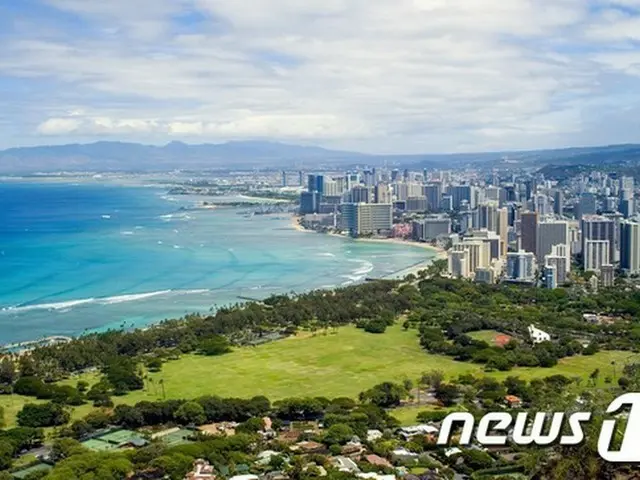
0 325 633 425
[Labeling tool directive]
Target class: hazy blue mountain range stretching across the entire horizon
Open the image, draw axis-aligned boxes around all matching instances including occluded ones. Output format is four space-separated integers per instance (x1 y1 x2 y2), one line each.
0 141 640 174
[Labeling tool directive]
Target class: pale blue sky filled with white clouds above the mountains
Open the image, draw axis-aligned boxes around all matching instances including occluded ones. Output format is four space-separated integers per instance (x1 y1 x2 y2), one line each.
0 0 640 153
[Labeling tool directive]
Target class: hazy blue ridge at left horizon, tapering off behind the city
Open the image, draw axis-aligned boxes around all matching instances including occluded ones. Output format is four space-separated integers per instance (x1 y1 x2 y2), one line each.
0 141 367 173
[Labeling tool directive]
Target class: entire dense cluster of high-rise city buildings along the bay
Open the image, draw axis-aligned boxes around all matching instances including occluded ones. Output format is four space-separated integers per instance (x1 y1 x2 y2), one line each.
300 168 640 288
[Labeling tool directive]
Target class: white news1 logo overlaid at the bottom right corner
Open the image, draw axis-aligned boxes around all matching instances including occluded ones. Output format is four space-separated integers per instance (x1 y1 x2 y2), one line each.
437 393 640 463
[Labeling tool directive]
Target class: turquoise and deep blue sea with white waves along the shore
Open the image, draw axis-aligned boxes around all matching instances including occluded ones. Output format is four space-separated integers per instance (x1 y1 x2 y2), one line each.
0 182 434 344
